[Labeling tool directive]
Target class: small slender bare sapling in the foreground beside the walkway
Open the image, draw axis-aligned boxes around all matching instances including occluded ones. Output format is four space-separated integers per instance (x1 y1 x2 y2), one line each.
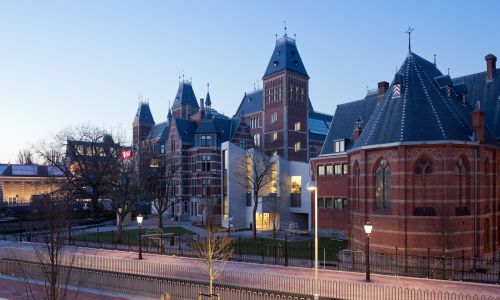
193 198 233 298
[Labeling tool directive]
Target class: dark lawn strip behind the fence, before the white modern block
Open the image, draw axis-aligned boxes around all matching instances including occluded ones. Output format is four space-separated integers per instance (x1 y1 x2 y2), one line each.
234 237 347 261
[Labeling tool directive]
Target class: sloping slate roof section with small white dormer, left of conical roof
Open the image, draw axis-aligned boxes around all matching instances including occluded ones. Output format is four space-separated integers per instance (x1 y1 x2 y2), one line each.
320 93 377 155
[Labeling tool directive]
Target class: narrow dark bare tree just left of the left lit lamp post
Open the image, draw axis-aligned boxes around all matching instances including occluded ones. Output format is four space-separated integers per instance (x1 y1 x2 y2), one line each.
110 155 145 242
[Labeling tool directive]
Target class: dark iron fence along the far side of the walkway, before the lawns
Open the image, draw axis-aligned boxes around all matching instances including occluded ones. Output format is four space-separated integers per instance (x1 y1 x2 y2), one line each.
2 228 500 284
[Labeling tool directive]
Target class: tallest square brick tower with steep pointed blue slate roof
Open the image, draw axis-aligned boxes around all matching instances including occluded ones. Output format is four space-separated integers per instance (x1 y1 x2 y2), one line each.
262 32 309 161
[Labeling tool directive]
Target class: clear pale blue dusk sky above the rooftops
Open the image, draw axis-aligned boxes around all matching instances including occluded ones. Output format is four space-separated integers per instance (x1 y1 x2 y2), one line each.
0 0 500 163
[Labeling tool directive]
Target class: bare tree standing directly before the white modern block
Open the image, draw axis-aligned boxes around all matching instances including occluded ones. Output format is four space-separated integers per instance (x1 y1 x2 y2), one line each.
236 148 279 239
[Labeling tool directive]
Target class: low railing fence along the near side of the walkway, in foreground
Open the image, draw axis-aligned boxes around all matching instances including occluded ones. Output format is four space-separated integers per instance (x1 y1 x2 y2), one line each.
0 254 500 300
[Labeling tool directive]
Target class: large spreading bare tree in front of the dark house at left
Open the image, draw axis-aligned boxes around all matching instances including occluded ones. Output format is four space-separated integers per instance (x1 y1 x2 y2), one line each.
33 125 120 216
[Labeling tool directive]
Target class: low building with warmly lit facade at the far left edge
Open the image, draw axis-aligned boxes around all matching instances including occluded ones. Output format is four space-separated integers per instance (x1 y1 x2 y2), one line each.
0 164 64 206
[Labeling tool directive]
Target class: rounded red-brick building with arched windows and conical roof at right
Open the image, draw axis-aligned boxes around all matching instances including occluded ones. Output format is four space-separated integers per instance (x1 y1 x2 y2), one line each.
311 50 500 257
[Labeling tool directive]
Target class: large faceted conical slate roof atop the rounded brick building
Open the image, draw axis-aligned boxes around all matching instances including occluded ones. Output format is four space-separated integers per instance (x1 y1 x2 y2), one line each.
354 52 497 147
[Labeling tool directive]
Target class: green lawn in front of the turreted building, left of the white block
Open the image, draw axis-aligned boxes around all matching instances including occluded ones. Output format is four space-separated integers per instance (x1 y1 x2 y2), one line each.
72 227 194 245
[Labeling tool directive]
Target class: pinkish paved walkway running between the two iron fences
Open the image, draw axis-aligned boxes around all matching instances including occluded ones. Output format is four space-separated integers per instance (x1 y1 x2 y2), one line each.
0 242 500 299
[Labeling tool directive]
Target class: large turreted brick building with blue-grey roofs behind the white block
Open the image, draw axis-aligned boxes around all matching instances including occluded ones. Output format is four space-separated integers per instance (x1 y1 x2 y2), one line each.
132 34 332 228
